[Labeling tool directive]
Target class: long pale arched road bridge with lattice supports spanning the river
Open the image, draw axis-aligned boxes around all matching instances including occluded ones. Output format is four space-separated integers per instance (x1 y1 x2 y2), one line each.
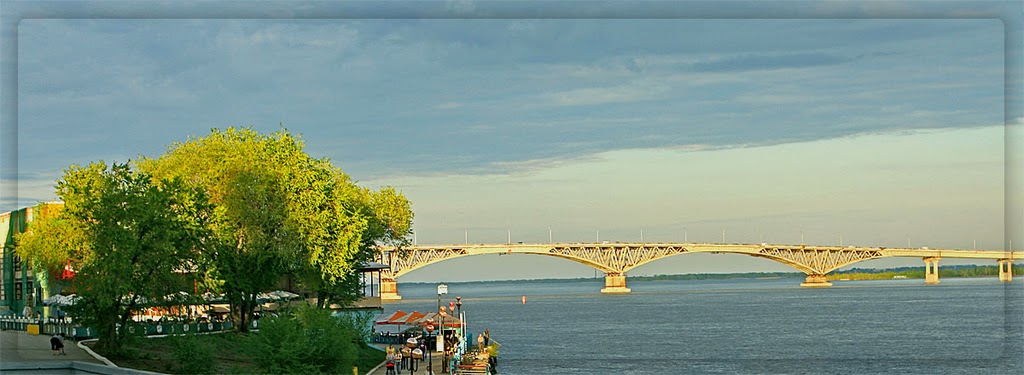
378 243 1024 300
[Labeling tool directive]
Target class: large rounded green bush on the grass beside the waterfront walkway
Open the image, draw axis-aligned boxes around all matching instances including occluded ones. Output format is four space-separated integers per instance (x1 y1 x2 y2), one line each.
250 306 359 374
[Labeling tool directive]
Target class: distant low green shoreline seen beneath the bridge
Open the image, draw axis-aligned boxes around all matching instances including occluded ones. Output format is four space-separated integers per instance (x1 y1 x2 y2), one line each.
403 265 1024 285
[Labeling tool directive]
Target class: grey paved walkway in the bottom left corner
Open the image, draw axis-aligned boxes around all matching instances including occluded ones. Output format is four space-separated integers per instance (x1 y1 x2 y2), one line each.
0 331 105 364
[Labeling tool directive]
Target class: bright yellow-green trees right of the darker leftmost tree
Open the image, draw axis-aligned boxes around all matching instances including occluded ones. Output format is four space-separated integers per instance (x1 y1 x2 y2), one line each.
140 128 412 330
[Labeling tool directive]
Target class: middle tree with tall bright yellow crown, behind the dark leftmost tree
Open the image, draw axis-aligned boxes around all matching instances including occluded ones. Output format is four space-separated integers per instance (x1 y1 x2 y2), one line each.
139 128 308 331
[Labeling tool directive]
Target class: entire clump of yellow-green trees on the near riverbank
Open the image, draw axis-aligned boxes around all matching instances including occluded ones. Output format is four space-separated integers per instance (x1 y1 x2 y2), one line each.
16 128 413 349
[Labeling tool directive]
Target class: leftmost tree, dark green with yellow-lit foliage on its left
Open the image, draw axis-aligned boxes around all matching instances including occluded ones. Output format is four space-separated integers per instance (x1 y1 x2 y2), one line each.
19 162 212 352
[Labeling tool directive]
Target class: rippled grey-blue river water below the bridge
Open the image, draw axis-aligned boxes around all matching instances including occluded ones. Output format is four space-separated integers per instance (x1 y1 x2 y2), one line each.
385 278 1024 374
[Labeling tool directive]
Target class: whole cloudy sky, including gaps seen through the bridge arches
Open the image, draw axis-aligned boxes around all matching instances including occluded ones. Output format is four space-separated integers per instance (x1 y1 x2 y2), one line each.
0 1 1024 282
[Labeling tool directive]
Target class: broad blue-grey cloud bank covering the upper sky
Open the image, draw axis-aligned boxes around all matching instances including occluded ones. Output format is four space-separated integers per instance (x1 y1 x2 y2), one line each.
12 19 1004 186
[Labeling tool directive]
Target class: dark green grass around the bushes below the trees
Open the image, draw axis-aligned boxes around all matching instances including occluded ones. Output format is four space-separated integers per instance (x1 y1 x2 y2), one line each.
90 333 384 374
